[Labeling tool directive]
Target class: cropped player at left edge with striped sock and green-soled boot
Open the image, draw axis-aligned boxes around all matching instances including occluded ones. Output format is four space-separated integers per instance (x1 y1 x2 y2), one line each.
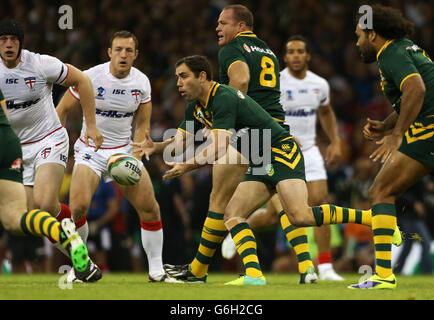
0 87 89 279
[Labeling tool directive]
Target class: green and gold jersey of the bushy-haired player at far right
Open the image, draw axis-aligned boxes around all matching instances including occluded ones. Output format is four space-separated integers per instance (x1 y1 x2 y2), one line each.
377 38 434 120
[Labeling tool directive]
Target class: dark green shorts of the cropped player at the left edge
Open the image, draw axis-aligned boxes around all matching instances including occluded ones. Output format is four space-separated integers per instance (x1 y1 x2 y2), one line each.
0 125 23 183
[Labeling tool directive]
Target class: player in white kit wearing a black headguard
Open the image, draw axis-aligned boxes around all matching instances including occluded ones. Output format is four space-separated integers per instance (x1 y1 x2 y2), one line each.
0 19 102 276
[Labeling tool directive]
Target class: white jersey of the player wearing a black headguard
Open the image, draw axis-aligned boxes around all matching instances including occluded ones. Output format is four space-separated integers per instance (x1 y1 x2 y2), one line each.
0 49 68 144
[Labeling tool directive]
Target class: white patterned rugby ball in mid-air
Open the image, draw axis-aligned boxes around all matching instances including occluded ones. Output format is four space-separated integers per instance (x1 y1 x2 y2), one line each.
107 153 142 186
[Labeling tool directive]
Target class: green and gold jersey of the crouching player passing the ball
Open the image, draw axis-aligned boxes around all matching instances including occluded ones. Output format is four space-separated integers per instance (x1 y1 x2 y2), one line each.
179 82 289 145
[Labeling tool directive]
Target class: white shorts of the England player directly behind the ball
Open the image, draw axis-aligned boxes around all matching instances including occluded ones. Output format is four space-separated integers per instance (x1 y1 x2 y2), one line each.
74 139 133 182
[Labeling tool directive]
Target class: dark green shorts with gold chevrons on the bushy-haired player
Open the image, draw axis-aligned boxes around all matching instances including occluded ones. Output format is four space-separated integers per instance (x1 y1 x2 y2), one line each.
398 117 434 167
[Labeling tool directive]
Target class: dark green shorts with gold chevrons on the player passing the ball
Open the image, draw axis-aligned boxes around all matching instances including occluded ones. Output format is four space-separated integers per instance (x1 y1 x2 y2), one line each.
243 137 306 190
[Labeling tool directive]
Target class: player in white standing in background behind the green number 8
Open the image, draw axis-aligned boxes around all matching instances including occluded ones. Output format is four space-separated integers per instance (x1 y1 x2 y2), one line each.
222 35 343 281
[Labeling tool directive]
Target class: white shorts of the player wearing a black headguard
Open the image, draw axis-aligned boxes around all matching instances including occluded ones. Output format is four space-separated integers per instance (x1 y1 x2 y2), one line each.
21 127 69 186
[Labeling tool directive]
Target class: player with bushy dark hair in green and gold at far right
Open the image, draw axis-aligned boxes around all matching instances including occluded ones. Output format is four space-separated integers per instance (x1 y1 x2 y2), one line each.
350 5 434 289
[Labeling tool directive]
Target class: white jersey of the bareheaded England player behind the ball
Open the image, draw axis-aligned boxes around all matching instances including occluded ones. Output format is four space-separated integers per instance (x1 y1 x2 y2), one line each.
69 62 151 148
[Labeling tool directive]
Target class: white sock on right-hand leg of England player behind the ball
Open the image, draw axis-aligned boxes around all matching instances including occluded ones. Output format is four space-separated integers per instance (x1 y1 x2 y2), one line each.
141 228 164 279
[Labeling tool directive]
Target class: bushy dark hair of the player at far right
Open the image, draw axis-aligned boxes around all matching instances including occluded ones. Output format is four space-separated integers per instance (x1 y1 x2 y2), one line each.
358 4 414 40
